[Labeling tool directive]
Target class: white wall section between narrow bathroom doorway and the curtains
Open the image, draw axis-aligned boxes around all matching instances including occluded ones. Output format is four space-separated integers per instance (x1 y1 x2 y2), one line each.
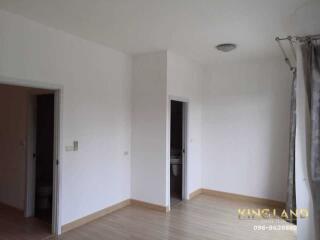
202 59 291 201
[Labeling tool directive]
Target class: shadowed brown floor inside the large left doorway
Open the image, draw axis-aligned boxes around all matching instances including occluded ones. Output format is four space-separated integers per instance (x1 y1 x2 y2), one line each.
0 204 51 240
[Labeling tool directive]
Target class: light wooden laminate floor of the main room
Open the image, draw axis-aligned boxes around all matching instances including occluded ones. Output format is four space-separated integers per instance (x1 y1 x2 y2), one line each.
52 195 296 240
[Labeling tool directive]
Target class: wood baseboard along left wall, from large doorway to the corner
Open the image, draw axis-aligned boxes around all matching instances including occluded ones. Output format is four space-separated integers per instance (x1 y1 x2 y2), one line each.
61 199 131 233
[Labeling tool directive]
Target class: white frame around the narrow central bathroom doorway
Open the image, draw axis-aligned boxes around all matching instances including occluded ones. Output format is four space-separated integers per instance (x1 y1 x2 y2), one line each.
167 95 189 209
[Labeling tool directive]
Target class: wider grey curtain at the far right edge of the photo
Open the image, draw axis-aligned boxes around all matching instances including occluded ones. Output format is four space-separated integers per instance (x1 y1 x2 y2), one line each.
301 40 320 234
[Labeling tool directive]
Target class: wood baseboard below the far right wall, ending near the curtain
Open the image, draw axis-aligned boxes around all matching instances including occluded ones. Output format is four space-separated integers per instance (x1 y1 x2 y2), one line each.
201 189 286 209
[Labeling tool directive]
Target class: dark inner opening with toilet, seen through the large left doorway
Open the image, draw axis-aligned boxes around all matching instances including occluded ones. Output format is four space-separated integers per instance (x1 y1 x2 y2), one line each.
35 94 54 224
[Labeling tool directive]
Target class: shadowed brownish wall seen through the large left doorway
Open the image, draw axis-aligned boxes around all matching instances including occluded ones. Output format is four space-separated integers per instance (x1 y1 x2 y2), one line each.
0 85 28 210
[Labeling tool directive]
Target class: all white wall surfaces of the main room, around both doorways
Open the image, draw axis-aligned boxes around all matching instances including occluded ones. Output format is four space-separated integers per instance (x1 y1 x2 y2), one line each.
0 4 306 235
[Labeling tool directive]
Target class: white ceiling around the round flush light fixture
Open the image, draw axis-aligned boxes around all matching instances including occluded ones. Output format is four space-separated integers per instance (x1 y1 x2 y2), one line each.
0 0 319 64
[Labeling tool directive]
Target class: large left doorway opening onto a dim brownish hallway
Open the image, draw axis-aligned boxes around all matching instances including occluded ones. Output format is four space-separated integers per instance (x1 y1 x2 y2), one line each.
0 81 60 240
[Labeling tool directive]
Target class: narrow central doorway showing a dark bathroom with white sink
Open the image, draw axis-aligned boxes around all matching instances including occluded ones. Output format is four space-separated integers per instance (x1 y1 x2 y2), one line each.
170 100 187 206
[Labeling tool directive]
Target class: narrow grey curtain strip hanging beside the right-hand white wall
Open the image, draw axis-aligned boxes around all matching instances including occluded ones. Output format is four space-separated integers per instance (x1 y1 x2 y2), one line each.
286 68 297 223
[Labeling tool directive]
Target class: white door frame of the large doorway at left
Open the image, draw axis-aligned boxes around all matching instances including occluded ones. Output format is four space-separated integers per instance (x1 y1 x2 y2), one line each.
0 75 63 235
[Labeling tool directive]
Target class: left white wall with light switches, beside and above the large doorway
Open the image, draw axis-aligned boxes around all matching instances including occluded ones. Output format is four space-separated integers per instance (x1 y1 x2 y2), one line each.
0 11 131 227
